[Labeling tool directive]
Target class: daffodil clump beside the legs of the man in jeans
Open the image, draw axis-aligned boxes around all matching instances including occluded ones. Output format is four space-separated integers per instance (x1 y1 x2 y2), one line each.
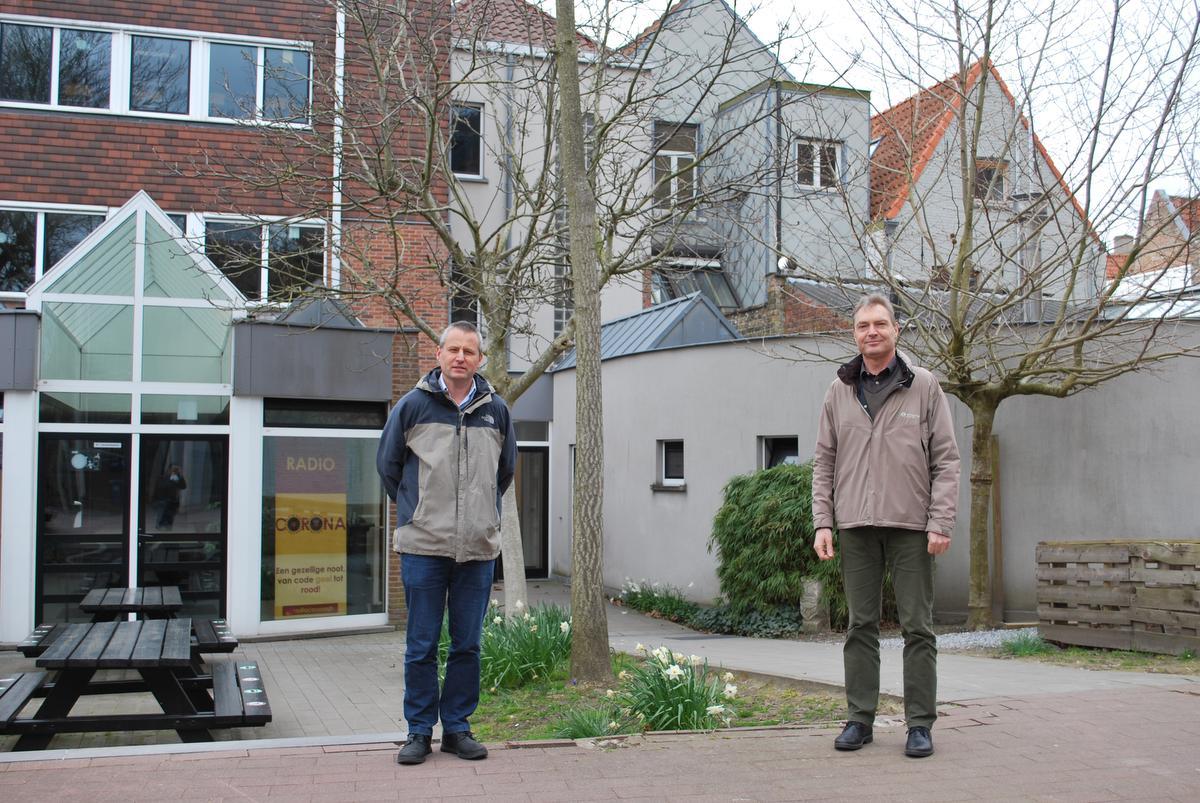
438 605 571 689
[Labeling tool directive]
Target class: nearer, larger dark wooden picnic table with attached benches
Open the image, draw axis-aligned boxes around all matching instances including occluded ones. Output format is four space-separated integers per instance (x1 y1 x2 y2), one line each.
0 618 271 750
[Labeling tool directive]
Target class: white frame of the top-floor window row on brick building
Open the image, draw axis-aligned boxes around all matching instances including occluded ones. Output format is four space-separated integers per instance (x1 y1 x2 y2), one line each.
0 14 313 128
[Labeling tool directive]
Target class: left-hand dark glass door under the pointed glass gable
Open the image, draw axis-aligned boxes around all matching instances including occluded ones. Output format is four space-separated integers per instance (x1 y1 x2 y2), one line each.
35 433 130 623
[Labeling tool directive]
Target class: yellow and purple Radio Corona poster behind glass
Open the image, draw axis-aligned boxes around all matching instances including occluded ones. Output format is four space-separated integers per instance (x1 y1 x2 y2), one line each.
275 441 347 619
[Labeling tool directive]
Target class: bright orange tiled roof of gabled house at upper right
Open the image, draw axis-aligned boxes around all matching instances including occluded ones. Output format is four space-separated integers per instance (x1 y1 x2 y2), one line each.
871 59 1099 241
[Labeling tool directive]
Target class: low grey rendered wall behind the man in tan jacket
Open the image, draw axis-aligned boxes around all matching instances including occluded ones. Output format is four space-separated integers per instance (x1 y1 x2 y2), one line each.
551 325 1200 622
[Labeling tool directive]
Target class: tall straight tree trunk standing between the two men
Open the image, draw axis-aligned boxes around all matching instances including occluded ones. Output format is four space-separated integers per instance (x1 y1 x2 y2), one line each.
554 0 612 682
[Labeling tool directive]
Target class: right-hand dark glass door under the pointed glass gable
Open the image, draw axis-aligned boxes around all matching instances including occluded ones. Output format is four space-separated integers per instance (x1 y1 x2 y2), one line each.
137 435 229 618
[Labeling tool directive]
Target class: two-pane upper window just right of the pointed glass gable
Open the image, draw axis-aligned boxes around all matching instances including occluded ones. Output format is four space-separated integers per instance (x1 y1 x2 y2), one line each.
204 221 325 301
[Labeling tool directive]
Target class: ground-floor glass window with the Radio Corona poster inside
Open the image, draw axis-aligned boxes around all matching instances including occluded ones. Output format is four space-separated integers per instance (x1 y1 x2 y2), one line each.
262 437 388 622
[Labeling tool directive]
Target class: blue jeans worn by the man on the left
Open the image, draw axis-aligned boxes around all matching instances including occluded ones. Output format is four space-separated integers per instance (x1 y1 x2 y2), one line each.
400 552 496 736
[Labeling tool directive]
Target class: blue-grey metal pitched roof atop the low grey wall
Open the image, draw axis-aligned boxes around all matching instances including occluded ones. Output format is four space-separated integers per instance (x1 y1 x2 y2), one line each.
551 293 742 371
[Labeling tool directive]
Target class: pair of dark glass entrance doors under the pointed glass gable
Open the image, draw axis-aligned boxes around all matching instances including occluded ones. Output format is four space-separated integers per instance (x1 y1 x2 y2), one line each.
35 432 229 623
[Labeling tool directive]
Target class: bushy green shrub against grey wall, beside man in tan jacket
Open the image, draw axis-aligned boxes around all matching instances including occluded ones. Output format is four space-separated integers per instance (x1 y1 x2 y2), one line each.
708 461 895 628
